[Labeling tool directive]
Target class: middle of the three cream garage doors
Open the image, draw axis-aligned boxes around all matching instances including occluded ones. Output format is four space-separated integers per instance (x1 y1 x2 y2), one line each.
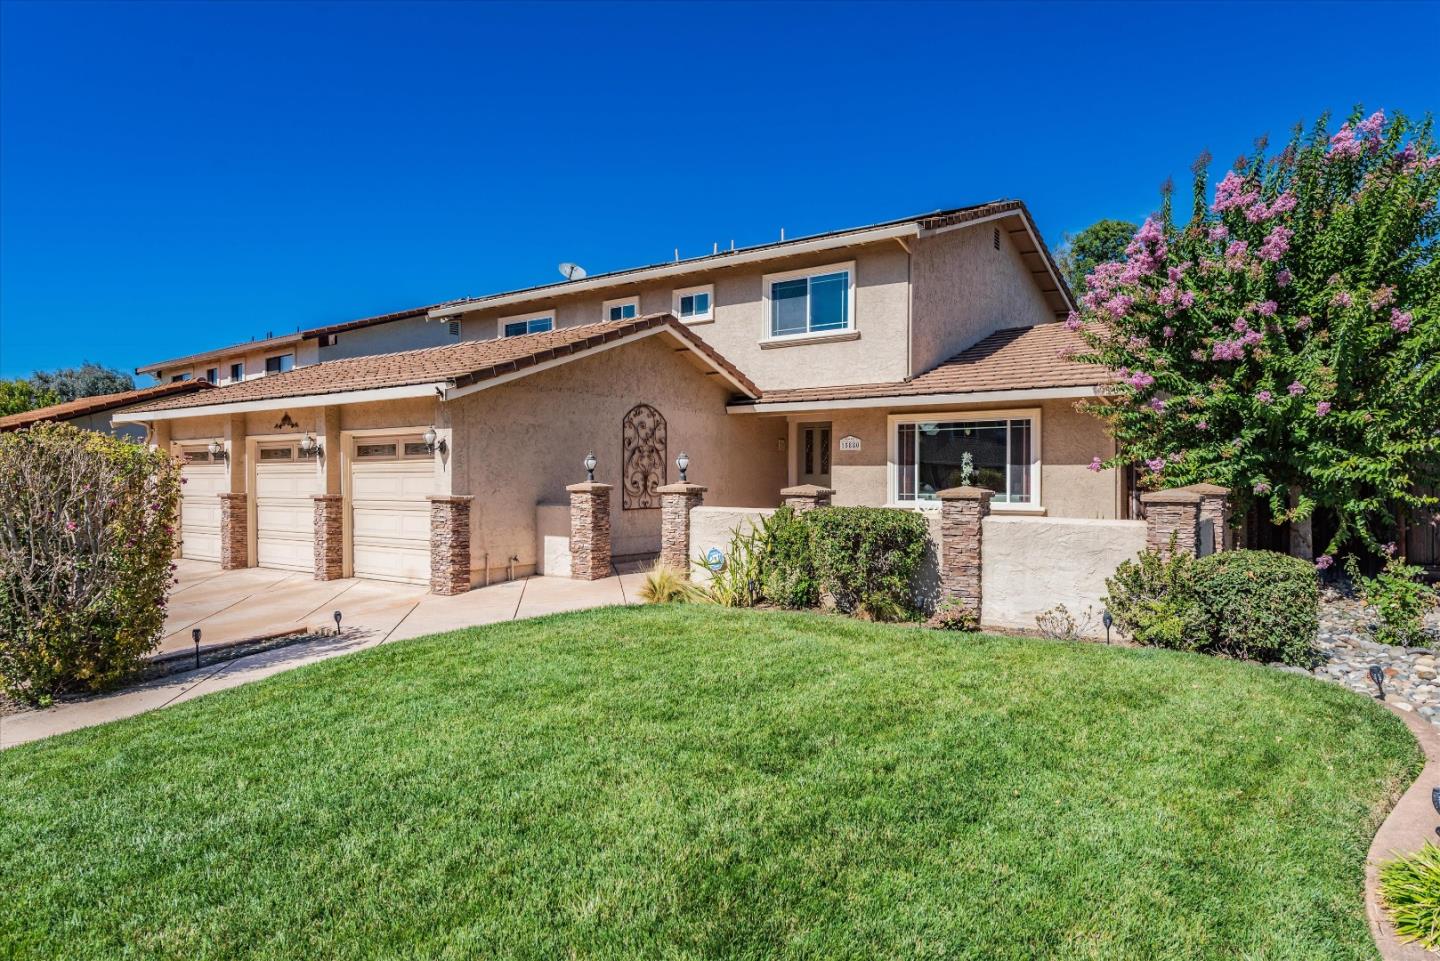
255 442 324 571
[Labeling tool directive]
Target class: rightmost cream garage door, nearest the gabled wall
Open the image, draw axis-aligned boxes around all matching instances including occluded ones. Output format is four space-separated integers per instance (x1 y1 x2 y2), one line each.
350 437 435 584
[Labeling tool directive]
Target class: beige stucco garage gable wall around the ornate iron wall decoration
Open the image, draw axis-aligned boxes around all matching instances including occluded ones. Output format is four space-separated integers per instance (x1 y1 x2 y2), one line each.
441 334 785 578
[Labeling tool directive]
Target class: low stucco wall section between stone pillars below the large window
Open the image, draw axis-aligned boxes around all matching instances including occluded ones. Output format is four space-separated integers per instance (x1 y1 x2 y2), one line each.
981 516 1145 637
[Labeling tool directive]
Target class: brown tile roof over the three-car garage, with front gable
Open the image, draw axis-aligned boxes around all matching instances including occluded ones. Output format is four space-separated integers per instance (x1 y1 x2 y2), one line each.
125 314 760 412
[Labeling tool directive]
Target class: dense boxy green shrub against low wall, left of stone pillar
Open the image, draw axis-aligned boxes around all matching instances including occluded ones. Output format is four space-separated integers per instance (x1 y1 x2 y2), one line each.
805 507 927 621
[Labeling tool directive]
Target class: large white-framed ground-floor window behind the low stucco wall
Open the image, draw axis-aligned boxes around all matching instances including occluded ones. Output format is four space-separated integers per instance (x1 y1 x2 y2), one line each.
896 416 1040 506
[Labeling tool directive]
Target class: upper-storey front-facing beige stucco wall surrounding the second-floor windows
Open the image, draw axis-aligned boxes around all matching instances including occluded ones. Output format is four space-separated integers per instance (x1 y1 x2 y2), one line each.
449 241 910 388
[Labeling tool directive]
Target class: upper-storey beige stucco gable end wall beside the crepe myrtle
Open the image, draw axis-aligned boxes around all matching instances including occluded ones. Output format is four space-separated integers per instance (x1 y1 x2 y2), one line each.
910 218 1056 375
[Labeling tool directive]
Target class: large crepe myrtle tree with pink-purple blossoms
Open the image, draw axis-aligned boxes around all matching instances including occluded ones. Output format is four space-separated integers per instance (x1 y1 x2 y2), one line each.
1066 109 1440 568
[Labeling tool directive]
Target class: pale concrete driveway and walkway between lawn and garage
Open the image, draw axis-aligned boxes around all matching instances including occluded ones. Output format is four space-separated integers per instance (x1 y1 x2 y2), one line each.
0 560 644 748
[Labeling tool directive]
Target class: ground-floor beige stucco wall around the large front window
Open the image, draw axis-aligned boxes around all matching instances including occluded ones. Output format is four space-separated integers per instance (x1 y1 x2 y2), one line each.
766 399 1119 517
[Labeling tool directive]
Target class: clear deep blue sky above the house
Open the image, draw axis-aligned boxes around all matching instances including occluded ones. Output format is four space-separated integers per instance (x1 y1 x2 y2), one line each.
0 0 1440 376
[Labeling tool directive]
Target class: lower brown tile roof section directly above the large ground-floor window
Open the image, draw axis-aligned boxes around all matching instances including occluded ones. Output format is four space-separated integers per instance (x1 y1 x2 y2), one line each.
756 323 1112 406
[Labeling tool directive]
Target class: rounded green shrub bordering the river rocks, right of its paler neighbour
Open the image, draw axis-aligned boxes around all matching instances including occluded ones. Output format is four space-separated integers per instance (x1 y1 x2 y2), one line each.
1194 550 1320 666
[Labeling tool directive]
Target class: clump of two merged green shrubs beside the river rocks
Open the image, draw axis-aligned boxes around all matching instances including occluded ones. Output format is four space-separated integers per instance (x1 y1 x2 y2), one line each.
1104 550 1320 666
